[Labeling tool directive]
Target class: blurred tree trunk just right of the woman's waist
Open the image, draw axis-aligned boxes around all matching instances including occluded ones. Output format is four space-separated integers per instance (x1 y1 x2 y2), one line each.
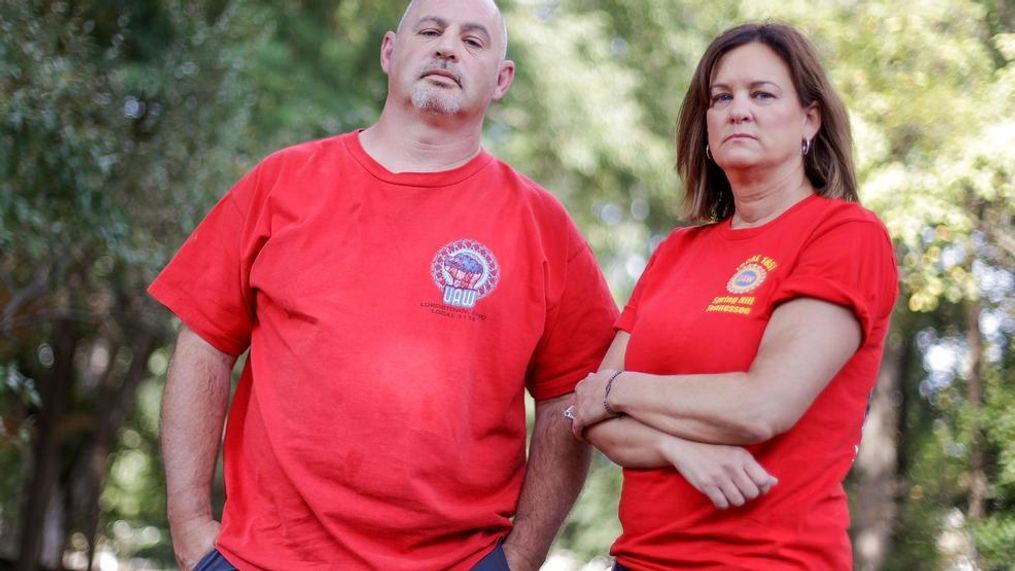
854 316 912 571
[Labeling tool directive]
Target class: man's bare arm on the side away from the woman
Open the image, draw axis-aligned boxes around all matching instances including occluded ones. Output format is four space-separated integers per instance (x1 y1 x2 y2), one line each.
160 326 235 570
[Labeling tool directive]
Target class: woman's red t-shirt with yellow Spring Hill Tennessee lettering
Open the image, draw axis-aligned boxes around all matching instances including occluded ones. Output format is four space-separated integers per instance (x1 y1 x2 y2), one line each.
612 196 897 570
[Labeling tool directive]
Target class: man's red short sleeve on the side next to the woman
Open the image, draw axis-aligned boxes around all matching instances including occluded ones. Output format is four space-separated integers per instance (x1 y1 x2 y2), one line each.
527 228 617 401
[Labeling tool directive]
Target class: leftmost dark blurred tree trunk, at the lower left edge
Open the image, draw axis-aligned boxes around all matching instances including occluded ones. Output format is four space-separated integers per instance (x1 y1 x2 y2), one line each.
16 320 78 571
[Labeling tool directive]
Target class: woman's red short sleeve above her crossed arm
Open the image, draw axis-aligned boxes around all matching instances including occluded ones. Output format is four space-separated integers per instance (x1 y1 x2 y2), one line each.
771 219 898 339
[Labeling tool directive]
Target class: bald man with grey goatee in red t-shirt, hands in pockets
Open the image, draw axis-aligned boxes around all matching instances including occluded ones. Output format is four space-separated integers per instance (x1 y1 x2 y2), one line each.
155 0 616 571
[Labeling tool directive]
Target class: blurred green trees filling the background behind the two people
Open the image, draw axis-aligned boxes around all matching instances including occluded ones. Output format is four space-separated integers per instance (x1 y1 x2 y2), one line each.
0 0 1015 571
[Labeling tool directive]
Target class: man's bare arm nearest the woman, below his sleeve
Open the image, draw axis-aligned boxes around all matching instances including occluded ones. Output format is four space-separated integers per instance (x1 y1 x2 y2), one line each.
503 395 592 571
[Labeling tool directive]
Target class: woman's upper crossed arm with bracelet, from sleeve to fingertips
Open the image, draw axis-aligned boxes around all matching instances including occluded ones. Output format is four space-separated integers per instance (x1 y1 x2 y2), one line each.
574 298 861 444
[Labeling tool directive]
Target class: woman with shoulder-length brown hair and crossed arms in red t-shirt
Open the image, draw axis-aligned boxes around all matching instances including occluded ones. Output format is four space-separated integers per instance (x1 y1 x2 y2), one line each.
570 23 897 570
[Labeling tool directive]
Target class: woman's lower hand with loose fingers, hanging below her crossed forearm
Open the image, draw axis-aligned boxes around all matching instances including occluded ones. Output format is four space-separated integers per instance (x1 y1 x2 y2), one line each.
661 437 779 509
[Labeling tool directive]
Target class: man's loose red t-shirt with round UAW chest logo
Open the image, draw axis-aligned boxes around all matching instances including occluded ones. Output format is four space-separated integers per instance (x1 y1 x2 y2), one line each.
149 133 617 570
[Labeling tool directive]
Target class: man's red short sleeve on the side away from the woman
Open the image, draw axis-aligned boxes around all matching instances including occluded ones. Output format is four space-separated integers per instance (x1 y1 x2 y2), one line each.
148 165 258 356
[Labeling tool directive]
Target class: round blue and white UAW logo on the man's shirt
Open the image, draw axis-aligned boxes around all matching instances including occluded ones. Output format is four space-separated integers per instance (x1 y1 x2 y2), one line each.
430 239 500 308
